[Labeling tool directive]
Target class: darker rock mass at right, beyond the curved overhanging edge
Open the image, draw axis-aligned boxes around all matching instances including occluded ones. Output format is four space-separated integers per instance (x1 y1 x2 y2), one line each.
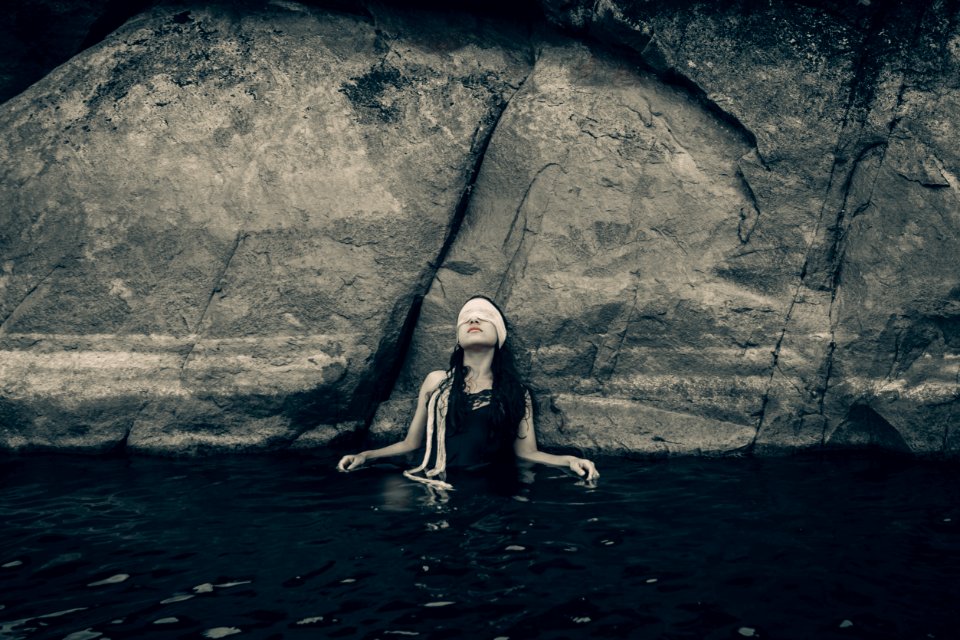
528 0 960 455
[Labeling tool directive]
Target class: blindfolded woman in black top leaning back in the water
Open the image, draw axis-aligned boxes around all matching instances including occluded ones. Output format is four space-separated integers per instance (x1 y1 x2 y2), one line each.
337 296 600 489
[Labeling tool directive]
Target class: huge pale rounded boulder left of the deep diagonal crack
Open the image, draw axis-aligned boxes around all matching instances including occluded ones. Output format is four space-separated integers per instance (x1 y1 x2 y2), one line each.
0 0 530 451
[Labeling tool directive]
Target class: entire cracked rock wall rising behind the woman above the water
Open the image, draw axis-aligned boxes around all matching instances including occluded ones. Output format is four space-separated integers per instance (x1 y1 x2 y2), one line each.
0 0 960 455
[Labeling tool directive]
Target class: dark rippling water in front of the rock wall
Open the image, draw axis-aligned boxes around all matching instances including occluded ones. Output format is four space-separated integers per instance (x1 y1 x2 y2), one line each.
0 457 960 640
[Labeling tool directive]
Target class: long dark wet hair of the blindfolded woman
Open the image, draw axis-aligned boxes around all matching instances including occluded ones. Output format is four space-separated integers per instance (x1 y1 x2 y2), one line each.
447 295 532 455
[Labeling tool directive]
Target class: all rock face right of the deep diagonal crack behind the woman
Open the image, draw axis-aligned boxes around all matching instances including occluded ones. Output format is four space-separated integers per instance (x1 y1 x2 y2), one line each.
374 0 960 454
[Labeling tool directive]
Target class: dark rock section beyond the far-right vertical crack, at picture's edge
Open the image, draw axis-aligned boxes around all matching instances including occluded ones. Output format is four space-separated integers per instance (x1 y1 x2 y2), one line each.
812 4 960 457
